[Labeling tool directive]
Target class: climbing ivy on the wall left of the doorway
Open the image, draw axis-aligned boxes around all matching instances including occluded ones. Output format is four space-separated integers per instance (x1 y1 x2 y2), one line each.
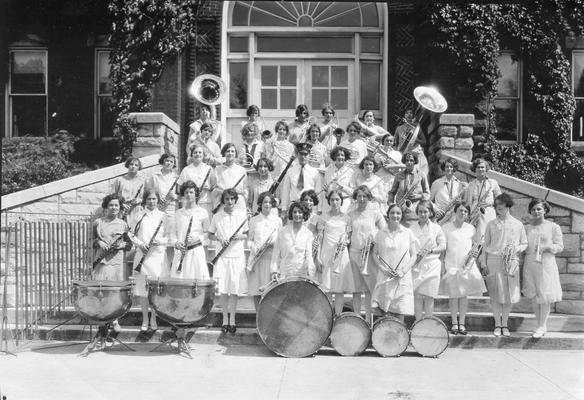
108 0 208 159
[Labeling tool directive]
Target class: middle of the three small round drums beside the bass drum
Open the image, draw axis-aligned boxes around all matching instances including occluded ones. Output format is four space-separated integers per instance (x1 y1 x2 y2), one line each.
371 317 410 357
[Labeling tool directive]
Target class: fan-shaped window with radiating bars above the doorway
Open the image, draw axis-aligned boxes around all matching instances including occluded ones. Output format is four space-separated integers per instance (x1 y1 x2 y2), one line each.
231 1 380 28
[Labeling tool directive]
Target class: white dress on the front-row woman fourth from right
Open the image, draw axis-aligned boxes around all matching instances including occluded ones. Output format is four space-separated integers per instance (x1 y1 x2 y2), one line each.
410 221 446 297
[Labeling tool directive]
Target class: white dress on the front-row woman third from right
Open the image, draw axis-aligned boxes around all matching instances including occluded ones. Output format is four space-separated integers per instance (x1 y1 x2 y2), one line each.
440 222 487 299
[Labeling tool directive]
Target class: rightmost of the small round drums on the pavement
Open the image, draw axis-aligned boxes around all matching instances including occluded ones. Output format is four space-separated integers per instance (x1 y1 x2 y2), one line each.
411 317 450 357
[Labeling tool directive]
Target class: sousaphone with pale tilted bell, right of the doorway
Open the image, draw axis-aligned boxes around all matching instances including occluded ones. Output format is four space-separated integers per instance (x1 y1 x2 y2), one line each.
398 86 448 154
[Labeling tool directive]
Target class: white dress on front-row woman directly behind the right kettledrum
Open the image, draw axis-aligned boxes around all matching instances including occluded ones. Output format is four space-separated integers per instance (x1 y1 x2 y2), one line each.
170 206 209 279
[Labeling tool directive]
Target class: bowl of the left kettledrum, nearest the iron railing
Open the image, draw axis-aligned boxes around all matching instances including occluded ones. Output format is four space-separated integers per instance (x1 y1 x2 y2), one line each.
71 281 132 322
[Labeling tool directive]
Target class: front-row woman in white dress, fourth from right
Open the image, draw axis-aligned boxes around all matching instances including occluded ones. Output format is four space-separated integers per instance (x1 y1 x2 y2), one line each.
410 200 446 321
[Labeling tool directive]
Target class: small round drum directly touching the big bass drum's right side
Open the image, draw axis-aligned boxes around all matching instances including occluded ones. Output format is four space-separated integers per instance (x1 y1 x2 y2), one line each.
331 312 371 356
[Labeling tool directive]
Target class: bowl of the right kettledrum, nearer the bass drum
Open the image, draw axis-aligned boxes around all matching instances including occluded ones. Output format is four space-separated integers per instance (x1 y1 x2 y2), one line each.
148 278 215 324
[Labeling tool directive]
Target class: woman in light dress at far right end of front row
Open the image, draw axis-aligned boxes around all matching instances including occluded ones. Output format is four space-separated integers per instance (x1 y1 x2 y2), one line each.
523 199 564 339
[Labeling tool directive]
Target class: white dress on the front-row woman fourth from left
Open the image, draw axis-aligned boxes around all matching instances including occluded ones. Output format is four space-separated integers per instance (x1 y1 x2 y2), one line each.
209 210 248 296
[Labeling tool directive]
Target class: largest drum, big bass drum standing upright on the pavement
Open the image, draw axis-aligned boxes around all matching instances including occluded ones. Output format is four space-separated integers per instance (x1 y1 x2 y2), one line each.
256 277 333 357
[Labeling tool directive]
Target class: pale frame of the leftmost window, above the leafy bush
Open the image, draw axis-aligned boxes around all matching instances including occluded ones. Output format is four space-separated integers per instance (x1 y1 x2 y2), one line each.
4 46 49 138
